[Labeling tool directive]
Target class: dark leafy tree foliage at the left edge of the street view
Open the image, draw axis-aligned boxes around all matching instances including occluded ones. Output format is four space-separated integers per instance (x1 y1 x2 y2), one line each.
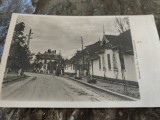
7 22 32 70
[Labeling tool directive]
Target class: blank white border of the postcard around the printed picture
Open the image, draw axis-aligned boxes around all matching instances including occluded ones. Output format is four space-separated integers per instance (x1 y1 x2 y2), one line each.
0 13 160 108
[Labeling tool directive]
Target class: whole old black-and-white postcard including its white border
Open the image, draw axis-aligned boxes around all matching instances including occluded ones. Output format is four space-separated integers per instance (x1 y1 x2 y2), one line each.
0 14 160 108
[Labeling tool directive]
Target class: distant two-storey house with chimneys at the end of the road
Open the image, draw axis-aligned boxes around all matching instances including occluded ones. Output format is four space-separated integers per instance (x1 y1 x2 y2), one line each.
34 49 64 75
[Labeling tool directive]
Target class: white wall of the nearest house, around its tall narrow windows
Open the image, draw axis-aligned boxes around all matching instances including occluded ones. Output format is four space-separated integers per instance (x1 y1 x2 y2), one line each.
90 49 136 81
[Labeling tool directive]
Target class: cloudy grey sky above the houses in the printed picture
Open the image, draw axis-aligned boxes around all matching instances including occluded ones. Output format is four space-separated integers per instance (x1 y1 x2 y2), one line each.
18 16 118 59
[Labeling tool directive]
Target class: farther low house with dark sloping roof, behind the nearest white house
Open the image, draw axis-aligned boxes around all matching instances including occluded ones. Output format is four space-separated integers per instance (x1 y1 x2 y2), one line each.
64 41 101 76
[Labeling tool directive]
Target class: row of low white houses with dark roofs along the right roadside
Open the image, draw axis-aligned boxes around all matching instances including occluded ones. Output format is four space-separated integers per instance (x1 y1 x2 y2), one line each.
64 30 137 84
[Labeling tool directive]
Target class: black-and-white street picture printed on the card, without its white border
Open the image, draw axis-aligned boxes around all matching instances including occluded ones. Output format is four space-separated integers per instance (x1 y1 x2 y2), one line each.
1 16 140 102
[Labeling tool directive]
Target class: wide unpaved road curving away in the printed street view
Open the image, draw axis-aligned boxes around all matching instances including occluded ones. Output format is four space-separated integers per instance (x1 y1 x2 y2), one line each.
2 73 125 101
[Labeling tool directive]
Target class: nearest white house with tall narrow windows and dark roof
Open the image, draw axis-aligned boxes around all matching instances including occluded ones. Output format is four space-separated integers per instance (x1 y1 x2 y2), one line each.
89 30 137 84
